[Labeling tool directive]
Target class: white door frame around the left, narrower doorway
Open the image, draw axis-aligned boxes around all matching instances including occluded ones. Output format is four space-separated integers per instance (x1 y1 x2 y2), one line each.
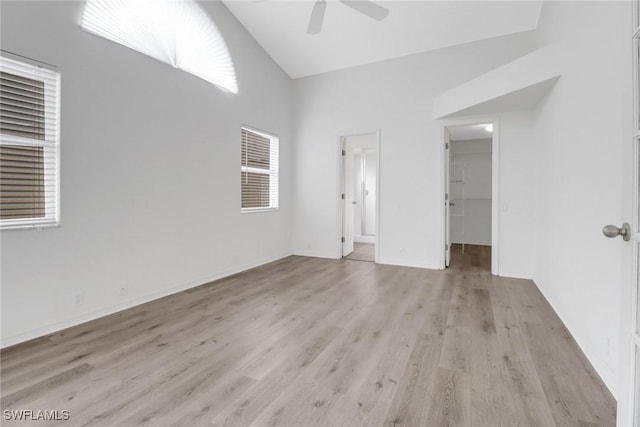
336 129 381 263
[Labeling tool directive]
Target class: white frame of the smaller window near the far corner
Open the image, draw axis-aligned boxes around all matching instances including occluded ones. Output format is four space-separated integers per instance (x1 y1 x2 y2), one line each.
240 124 280 214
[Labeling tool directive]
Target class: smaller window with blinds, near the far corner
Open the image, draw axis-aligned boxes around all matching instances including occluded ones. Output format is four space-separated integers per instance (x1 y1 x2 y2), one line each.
240 127 279 212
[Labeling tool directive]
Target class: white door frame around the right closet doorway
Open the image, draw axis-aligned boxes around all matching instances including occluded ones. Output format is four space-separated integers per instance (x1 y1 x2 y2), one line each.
437 116 500 276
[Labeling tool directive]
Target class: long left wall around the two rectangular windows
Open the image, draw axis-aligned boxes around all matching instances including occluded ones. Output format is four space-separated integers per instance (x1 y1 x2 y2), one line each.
1 1 293 346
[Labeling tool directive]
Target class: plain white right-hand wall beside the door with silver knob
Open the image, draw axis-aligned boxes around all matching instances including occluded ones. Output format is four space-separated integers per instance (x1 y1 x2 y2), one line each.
535 2 632 395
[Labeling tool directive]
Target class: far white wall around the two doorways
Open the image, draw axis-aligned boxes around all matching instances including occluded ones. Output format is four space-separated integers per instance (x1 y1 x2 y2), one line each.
293 33 535 277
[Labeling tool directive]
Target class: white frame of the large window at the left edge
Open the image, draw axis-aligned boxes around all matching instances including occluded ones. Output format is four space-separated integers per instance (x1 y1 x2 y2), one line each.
0 50 60 231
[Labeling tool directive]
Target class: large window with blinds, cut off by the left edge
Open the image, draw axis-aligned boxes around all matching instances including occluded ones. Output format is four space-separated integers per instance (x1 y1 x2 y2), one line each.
0 53 59 229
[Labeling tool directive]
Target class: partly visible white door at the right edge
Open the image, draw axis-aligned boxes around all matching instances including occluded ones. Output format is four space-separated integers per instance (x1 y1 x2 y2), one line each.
610 5 640 426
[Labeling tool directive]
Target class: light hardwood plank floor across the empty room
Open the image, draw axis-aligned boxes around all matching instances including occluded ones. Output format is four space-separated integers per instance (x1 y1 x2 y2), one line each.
1 245 615 427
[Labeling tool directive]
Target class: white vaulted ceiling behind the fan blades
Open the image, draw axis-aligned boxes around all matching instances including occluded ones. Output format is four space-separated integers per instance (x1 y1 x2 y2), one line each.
222 0 542 78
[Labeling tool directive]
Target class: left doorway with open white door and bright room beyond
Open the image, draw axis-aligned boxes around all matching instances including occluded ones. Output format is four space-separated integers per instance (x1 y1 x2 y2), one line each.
340 132 379 262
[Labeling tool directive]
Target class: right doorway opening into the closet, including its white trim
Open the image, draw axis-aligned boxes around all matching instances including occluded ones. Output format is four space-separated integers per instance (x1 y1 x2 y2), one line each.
443 121 498 274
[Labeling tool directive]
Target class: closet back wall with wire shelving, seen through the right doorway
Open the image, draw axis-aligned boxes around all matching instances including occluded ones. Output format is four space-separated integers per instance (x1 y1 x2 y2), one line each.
449 139 492 246
